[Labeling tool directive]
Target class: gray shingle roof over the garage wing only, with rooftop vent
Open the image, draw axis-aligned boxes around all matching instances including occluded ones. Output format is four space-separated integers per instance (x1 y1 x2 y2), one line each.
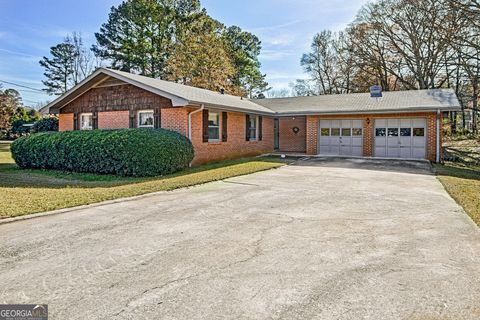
252 89 460 115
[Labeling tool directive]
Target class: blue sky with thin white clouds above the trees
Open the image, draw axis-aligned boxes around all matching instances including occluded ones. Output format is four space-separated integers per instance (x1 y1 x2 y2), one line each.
0 0 367 105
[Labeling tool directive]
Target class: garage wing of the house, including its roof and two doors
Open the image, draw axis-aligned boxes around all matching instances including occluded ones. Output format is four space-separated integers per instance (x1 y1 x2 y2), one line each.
255 89 460 162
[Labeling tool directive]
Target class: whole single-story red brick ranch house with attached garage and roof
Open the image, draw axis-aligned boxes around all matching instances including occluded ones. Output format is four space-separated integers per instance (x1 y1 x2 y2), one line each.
45 68 460 164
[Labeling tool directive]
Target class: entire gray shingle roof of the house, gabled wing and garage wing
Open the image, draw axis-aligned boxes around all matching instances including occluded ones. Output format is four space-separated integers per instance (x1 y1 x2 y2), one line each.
43 68 460 115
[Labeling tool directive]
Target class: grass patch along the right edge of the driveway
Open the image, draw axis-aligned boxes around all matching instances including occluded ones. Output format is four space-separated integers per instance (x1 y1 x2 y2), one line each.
434 140 480 226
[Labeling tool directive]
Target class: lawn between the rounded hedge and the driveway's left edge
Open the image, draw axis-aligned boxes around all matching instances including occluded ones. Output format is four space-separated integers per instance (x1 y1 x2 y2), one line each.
0 142 285 218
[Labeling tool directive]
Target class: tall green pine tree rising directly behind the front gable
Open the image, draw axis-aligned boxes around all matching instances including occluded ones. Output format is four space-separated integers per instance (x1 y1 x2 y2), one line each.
92 0 200 79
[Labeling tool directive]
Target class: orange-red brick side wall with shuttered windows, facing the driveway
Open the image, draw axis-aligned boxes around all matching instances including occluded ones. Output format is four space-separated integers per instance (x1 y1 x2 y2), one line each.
192 112 273 165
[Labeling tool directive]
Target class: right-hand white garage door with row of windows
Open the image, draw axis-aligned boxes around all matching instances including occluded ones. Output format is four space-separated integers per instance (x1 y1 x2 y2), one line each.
374 119 427 159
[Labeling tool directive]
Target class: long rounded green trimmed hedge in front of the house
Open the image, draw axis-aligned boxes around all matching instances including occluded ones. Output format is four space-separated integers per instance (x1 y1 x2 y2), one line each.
11 129 194 176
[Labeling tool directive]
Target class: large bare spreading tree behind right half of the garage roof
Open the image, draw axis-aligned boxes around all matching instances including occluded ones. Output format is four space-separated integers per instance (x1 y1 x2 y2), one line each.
367 0 456 89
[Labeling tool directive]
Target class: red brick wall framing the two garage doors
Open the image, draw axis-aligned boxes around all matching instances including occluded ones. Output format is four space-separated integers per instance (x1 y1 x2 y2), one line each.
306 112 441 162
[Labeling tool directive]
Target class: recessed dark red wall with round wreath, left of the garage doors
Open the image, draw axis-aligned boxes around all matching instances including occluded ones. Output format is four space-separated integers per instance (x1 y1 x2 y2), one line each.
279 117 307 152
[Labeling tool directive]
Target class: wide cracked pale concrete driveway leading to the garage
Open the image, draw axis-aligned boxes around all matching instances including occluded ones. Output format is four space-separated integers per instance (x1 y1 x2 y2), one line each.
0 159 480 320
